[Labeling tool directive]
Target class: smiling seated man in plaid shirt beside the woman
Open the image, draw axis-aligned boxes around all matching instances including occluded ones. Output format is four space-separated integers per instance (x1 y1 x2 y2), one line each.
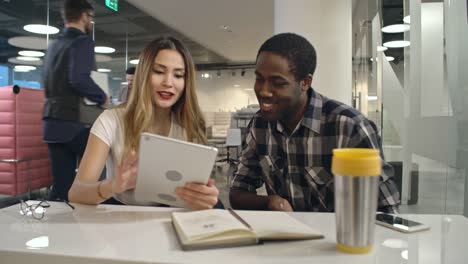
229 33 400 212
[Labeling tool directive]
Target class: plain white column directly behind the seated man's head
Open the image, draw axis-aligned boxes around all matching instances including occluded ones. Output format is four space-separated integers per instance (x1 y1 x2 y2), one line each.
275 0 352 105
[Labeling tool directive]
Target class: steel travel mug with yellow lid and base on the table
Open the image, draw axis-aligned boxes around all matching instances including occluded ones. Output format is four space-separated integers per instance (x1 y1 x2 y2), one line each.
332 148 382 254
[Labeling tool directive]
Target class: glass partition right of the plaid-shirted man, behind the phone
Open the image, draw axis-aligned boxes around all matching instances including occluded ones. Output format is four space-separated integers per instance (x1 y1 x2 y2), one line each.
353 0 468 215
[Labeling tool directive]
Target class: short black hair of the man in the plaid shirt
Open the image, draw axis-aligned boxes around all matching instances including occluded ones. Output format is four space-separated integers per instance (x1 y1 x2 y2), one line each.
257 33 317 81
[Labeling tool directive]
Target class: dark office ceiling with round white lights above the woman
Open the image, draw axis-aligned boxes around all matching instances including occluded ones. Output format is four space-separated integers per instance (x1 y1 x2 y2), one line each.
0 0 231 77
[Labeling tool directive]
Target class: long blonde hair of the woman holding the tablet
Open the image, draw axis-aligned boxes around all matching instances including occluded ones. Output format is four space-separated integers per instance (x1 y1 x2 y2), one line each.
122 37 207 162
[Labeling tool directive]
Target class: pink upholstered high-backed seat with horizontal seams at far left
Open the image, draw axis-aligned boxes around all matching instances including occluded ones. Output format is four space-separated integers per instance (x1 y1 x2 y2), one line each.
0 85 52 195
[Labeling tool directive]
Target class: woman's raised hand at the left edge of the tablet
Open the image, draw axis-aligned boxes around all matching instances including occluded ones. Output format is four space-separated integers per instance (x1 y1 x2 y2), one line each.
112 150 138 193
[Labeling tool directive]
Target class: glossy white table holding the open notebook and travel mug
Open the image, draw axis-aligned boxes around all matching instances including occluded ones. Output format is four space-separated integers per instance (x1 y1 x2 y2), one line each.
0 203 468 264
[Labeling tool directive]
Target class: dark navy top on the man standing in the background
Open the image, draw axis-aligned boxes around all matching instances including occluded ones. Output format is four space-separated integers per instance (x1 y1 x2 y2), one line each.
43 27 106 143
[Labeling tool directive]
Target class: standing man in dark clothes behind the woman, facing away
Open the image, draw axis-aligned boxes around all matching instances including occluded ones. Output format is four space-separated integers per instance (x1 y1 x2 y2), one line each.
43 0 109 200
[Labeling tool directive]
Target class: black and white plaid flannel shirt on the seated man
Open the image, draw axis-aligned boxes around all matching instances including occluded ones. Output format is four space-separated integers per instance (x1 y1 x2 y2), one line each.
231 89 400 212
